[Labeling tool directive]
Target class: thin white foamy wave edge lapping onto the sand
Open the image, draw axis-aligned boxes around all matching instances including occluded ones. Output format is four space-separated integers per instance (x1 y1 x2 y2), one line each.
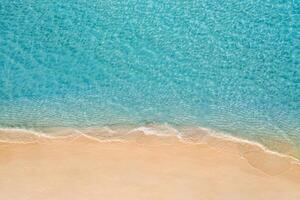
0 124 300 165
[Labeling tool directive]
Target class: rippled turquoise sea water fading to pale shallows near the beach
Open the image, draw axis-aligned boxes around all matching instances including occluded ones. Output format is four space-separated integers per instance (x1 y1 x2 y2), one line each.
0 0 300 154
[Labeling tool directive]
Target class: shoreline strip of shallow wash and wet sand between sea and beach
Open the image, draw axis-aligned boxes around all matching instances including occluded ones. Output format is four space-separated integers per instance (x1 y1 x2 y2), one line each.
0 124 300 164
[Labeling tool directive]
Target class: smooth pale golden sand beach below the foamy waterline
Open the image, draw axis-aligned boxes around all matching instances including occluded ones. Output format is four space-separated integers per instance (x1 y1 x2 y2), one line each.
0 128 300 200
